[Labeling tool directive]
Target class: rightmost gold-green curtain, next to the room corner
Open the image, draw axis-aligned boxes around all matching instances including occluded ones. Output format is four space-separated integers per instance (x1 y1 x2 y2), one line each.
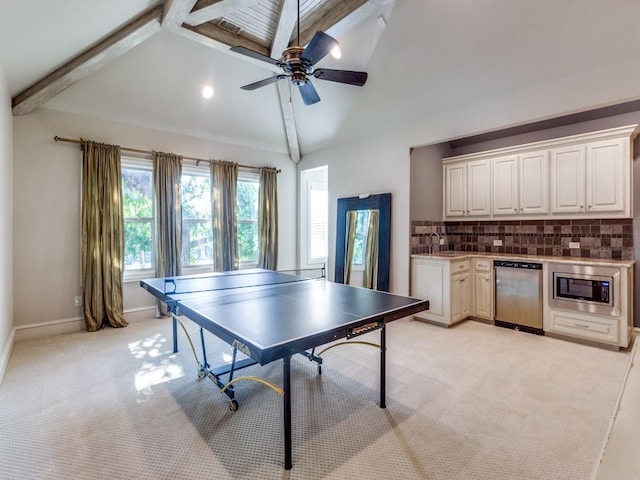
258 168 278 270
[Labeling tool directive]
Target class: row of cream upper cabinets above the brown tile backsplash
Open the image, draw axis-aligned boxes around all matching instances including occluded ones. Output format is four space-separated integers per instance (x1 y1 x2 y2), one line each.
443 125 637 220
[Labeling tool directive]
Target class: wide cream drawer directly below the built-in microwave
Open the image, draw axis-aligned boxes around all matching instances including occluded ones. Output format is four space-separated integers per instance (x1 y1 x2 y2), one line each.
549 310 620 344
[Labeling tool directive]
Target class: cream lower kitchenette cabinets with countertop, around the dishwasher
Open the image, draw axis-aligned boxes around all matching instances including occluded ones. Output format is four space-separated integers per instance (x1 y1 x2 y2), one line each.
410 252 634 348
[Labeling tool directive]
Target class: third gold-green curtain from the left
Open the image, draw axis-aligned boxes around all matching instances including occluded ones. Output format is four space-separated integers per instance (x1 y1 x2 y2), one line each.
210 160 238 272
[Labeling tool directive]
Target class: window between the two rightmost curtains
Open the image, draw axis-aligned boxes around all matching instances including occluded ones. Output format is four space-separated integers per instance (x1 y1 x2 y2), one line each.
236 172 260 267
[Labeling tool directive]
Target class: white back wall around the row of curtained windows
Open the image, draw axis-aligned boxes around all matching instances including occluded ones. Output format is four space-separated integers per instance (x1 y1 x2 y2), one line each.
11 109 297 333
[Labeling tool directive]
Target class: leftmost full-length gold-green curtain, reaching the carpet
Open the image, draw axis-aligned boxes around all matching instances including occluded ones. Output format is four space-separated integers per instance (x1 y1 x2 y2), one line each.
81 141 128 332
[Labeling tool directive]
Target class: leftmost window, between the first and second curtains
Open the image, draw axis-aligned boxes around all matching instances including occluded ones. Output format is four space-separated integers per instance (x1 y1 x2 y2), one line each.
122 158 154 273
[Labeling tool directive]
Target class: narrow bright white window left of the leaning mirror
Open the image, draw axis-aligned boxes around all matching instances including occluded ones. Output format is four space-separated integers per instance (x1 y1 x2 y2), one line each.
307 181 329 263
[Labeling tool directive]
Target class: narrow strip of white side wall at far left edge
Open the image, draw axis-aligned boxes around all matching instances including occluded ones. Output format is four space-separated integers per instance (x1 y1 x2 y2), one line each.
0 65 13 382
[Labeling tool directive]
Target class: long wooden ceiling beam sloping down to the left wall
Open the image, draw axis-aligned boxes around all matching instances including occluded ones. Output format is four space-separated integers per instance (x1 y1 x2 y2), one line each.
12 5 163 115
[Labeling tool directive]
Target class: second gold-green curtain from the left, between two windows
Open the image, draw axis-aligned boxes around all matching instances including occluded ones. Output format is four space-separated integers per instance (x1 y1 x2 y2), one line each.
152 152 182 277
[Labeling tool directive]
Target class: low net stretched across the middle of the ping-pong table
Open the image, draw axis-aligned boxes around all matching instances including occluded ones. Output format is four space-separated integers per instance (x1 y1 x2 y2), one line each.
164 267 325 295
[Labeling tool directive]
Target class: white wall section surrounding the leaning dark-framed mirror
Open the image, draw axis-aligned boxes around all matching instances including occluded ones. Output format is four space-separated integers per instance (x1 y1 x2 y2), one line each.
300 135 410 294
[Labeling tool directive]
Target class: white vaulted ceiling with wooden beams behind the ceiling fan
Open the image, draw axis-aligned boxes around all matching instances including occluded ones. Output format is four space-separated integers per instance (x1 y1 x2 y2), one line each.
0 0 640 161
